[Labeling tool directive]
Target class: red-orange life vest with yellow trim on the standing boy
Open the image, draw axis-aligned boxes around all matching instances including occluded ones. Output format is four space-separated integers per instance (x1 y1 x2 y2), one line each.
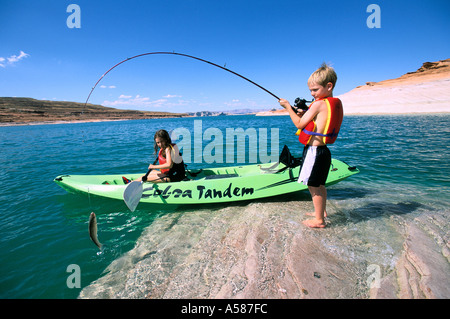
296 97 344 145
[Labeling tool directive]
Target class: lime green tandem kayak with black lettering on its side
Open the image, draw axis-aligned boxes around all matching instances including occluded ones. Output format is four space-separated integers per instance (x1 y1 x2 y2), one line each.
54 149 359 204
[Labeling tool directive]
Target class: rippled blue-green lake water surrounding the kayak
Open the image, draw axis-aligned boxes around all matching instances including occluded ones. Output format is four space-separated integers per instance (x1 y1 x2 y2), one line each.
0 114 450 298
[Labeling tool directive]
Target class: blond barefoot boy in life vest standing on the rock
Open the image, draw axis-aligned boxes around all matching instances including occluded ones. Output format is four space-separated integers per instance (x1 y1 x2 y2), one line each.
279 63 343 228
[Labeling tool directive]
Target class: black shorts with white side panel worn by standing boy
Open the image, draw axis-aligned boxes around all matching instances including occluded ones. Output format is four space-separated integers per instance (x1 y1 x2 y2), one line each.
298 145 331 187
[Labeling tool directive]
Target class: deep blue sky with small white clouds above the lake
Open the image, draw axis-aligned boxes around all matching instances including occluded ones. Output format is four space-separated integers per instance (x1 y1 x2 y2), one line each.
0 0 450 112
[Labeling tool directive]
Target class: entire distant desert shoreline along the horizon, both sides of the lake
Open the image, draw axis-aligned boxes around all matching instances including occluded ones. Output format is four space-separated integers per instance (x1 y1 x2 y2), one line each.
0 59 450 126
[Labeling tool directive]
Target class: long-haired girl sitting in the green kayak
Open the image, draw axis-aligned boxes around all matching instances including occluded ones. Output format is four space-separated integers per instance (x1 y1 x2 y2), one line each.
134 130 186 183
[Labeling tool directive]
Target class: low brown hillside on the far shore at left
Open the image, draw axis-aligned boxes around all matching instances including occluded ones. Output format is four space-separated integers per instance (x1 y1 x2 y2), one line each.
0 97 186 125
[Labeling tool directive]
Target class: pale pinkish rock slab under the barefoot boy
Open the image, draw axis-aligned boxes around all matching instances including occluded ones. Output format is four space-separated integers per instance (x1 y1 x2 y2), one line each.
80 201 450 299
